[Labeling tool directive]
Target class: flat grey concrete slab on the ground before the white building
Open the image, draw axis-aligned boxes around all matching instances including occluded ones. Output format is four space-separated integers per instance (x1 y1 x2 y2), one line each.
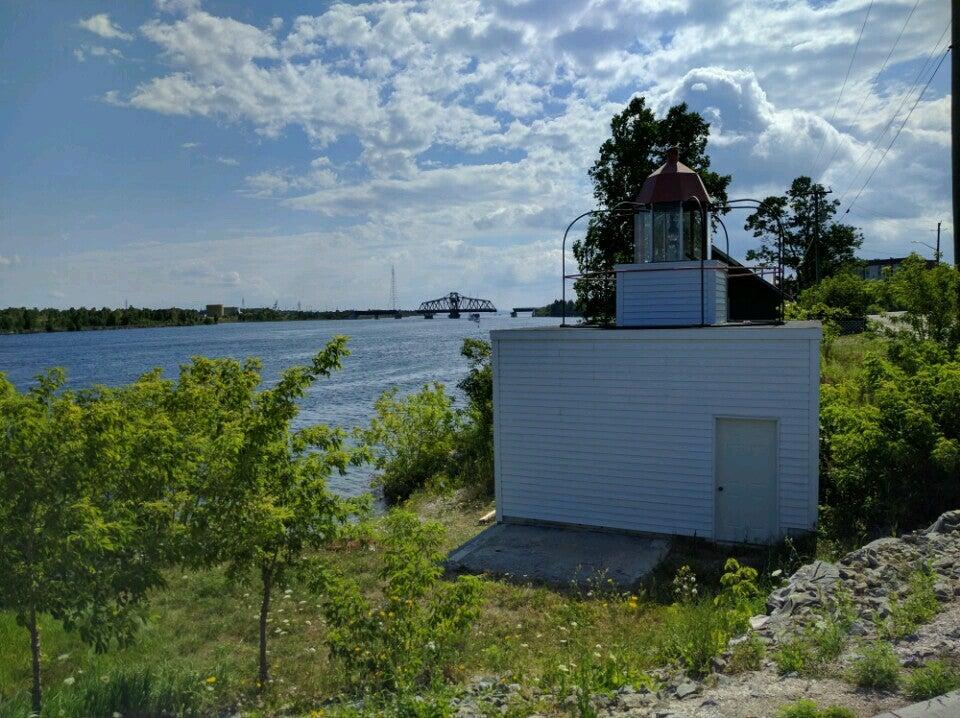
446 524 671 590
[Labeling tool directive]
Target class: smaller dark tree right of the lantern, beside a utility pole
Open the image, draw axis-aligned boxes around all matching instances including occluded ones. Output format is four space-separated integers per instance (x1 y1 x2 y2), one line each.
744 176 863 291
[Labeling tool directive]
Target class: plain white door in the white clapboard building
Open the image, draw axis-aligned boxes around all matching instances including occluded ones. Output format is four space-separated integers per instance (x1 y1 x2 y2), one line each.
716 418 778 543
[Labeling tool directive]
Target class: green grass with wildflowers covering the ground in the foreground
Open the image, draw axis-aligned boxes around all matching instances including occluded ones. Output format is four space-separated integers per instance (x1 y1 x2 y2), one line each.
0 494 816 718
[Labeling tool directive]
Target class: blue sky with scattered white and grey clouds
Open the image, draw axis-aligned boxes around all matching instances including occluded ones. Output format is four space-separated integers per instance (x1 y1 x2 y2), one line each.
0 0 952 308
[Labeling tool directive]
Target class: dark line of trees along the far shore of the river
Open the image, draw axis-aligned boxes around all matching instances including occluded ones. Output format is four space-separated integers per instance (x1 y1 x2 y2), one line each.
0 302 573 334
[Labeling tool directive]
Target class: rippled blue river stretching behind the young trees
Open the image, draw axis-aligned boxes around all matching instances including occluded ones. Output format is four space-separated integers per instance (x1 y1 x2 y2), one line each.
0 314 560 494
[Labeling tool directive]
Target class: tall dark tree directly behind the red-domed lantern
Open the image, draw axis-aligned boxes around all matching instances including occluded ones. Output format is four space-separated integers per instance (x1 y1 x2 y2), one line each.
573 97 730 323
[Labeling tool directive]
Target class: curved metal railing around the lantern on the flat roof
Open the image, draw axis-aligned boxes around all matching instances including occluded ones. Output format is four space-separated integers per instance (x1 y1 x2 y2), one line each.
560 197 785 326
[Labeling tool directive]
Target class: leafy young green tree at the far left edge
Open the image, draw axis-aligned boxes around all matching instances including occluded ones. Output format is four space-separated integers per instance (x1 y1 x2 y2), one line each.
0 369 180 714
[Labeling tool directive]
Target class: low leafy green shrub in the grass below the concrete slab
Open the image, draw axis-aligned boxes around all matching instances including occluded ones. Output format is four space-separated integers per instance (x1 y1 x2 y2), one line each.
323 510 482 693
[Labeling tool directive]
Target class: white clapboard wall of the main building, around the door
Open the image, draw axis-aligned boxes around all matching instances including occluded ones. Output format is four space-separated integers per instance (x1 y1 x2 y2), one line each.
491 324 821 538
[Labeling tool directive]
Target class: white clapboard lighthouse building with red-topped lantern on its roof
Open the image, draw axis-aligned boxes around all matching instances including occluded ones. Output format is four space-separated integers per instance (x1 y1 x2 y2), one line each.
491 150 821 543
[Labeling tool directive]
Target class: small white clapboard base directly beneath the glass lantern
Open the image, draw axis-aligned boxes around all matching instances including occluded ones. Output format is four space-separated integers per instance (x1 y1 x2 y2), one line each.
614 259 727 327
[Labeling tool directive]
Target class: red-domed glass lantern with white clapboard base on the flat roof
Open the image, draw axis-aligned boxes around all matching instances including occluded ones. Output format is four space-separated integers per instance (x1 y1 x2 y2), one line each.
614 147 727 327
